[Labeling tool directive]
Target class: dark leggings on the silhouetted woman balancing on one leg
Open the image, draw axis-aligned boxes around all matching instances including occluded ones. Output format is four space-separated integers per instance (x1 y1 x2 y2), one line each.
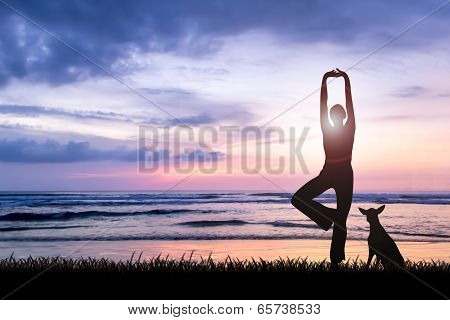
291 162 353 263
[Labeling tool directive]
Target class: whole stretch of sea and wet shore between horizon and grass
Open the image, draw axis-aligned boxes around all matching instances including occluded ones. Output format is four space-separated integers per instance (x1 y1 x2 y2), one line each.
0 191 450 261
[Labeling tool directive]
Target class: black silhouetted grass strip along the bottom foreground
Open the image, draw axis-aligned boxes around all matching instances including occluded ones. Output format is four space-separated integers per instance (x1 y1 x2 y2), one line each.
0 254 450 299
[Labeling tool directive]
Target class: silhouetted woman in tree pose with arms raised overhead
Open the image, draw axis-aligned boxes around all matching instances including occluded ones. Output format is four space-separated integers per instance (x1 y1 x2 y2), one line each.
291 69 355 263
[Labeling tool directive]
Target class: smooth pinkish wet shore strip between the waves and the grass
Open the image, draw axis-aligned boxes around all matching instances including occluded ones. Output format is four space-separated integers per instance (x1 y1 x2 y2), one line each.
0 239 450 262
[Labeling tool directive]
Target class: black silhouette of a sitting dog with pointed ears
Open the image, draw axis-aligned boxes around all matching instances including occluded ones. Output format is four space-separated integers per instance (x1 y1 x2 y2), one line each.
359 205 405 270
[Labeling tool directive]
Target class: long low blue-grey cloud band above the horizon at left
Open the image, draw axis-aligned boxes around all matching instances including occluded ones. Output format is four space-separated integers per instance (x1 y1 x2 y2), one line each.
0 138 224 163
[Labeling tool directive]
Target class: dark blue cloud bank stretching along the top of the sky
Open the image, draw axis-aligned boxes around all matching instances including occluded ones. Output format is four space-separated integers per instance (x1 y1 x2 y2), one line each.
0 0 449 85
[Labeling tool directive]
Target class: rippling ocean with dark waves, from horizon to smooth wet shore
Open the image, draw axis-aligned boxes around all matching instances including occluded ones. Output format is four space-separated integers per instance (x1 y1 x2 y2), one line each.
0 191 450 256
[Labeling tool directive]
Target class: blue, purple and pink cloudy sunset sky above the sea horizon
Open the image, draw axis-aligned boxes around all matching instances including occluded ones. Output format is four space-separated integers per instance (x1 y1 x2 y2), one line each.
0 0 450 192
